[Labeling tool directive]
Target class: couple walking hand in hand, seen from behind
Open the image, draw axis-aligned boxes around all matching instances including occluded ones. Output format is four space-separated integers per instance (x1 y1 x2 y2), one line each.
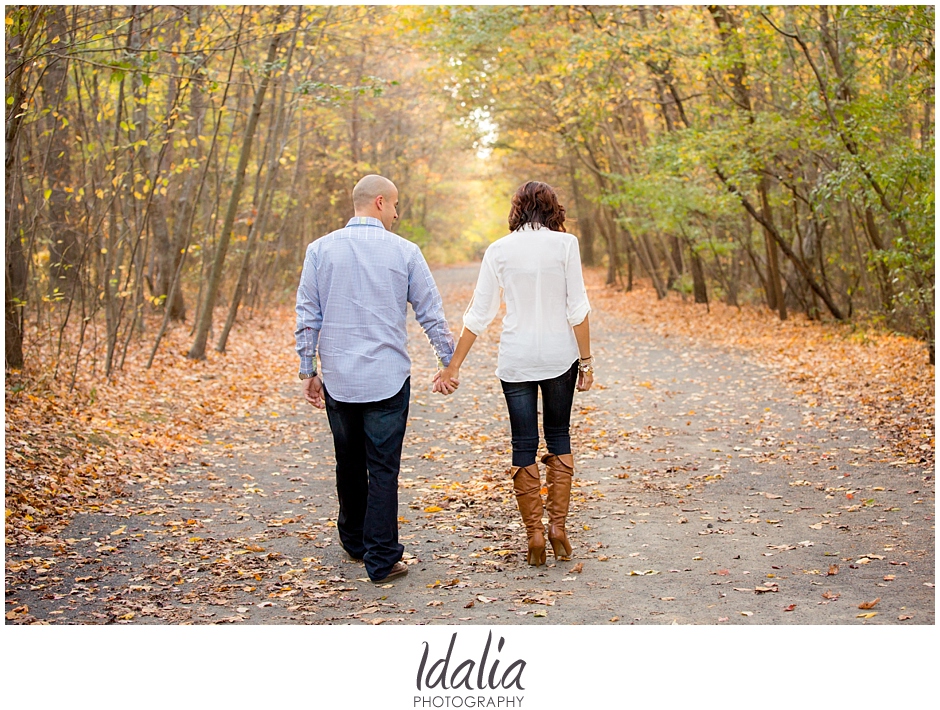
295 175 594 583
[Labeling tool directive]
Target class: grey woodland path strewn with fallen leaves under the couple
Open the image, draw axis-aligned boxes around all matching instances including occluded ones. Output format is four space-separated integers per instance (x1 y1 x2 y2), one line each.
7 266 935 624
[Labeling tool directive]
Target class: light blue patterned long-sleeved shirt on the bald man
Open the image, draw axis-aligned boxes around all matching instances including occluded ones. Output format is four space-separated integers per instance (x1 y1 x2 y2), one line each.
294 217 454 402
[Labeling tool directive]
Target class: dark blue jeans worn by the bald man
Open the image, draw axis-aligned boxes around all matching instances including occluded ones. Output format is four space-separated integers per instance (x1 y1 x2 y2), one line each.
324 378 411 579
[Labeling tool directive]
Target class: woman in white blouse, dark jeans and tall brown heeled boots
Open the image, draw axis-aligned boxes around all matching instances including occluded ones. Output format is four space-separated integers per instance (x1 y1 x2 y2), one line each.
435 182 594 566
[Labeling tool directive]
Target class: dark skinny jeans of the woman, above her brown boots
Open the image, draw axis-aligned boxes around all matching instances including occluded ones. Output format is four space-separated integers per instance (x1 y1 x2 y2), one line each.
500 361 578 466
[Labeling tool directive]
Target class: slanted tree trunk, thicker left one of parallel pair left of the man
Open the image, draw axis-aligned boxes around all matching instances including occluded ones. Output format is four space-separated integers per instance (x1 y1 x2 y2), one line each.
187 8 284 360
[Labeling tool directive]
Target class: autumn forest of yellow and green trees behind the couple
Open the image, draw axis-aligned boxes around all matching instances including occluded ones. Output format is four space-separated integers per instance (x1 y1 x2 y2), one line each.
4 5 935 544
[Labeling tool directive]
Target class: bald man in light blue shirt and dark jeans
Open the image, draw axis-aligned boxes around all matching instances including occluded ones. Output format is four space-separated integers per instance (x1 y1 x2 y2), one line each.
295 175 454 584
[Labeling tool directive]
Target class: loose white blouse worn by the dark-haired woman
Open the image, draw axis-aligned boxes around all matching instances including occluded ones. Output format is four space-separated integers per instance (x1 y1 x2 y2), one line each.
463 225 591 382
